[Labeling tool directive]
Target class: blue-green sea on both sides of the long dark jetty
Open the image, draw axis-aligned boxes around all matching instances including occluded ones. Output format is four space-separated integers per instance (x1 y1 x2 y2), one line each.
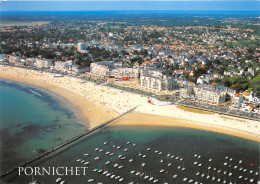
0 80 260 184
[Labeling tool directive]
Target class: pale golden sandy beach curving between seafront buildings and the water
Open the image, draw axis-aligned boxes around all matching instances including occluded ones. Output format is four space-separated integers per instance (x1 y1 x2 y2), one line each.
0 66 260 142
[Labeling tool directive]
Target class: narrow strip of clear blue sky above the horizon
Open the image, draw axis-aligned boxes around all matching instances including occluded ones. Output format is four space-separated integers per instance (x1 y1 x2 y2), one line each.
0 0 260 12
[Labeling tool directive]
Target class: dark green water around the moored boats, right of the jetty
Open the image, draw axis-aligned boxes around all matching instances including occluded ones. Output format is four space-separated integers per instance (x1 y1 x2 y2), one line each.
3 126 259 184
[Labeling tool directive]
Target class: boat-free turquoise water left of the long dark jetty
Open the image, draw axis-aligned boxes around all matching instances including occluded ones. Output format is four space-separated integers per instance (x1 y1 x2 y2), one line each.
0 80 85 171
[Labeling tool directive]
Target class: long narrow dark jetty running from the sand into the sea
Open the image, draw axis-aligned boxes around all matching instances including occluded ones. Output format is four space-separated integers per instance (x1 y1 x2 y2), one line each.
0 106 138 178
